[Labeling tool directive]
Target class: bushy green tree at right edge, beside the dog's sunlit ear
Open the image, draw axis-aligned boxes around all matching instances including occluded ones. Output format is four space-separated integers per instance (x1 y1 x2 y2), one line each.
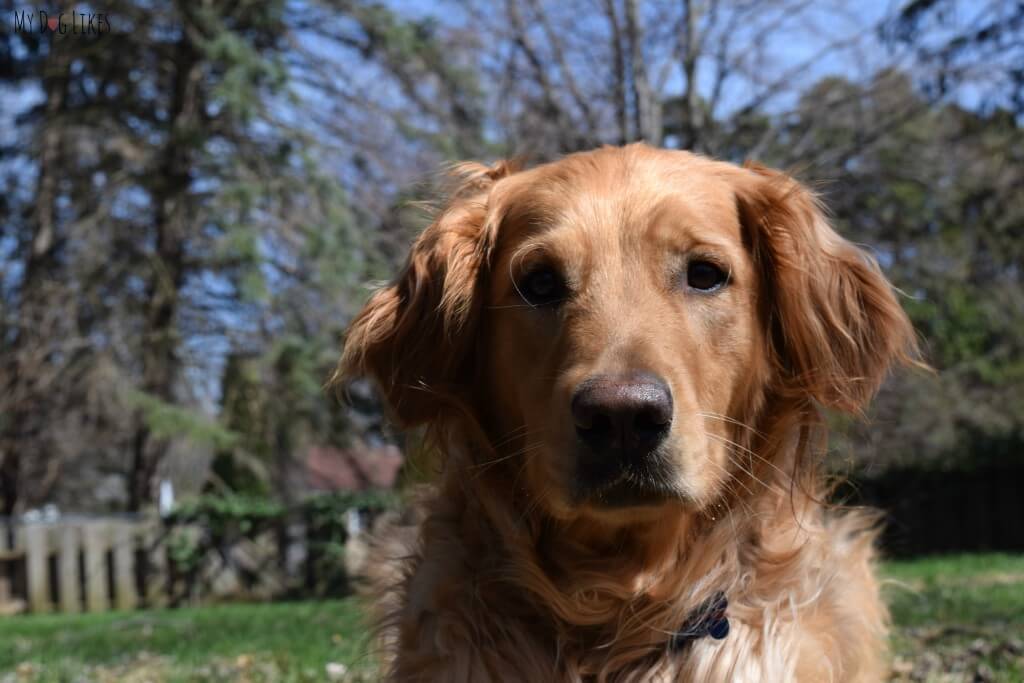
769 71 1024 469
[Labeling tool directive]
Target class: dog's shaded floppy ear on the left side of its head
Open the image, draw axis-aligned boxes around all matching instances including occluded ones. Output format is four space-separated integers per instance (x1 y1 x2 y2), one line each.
332 162 515 427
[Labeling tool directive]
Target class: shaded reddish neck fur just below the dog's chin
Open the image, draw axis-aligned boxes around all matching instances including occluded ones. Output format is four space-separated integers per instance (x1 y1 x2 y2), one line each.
445 462 751 618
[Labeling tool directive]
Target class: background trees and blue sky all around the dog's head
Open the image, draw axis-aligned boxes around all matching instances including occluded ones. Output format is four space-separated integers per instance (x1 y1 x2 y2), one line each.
0 0 1024 514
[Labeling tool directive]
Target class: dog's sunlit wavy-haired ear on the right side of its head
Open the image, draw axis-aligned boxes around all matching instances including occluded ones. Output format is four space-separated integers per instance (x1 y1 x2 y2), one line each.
735 165 918 413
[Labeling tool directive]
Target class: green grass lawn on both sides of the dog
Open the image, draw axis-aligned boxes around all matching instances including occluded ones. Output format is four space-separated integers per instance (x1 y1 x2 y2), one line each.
0 555 1024 683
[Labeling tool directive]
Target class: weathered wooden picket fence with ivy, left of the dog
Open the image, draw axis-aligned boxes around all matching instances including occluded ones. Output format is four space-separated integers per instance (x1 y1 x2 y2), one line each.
0 510 376 615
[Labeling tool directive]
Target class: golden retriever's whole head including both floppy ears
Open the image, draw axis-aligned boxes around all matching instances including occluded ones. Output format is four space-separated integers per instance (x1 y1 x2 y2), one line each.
339 145 913 519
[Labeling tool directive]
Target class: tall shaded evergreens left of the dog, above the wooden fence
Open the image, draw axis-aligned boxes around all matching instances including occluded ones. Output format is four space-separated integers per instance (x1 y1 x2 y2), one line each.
0 0 368 511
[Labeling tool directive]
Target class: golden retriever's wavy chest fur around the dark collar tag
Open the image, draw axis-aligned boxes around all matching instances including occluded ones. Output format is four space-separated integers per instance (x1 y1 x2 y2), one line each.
376 493 885 682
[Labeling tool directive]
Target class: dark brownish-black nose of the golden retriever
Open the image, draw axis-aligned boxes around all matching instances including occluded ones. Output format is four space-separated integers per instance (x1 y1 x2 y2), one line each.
572 375 672 460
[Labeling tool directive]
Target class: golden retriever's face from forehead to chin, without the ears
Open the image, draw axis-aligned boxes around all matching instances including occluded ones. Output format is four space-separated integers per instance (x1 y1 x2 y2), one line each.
480 156 767 513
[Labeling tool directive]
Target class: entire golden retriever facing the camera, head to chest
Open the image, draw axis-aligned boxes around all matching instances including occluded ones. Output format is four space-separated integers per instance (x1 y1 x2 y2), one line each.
336 144 916 683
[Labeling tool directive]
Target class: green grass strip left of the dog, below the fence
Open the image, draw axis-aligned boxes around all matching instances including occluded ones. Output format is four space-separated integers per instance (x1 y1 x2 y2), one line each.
0 600 376 683
